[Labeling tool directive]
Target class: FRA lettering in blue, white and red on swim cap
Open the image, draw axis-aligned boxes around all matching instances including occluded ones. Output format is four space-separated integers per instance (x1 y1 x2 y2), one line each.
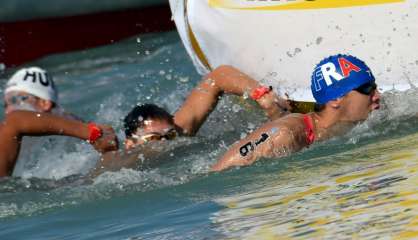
314 57 361 91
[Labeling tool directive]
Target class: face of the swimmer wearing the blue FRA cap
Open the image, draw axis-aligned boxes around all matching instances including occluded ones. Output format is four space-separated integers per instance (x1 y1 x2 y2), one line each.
344 82 380 122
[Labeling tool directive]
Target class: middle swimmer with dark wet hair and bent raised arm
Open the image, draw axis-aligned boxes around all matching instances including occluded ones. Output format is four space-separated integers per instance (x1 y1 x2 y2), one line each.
93 66 291 175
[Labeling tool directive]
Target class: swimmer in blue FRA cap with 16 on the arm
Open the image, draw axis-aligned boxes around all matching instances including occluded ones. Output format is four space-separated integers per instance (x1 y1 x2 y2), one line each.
212 54 380 171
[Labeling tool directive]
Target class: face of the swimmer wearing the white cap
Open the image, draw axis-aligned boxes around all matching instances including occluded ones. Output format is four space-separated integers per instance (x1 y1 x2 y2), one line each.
4 91 54 114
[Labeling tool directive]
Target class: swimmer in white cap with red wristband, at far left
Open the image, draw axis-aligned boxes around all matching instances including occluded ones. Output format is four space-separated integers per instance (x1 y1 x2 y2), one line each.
0 67 117 177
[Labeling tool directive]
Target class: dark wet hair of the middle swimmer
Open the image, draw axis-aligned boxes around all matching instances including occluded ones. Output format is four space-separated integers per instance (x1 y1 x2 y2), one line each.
123 104 174 138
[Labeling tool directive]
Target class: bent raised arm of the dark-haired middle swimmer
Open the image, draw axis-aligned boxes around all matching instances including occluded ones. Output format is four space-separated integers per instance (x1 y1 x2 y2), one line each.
174 66 290 135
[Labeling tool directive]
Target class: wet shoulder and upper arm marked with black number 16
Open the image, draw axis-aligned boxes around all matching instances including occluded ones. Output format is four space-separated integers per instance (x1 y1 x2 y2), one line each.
212 116 306 171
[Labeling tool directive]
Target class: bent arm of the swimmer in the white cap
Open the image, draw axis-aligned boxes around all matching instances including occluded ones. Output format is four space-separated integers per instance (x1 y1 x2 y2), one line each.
0 111 118 177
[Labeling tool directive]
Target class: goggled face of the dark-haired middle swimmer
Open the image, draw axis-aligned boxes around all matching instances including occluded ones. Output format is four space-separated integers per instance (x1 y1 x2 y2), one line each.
125 119 177 150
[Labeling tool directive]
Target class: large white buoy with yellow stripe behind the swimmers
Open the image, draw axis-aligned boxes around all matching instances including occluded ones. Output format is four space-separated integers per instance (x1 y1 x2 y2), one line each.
170 0 418 101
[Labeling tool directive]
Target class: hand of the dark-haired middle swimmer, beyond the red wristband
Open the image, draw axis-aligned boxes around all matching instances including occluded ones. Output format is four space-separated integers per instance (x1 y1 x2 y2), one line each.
257 91 292 120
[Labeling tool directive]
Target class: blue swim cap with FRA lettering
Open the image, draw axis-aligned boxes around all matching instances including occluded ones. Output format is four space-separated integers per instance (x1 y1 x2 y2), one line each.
311 54 375 104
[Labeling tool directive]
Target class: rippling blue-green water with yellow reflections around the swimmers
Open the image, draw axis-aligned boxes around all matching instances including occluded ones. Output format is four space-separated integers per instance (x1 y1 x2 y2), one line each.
0 32 418 239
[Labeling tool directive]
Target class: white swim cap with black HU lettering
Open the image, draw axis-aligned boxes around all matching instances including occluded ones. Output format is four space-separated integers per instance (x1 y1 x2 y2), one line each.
5 67 58 103
